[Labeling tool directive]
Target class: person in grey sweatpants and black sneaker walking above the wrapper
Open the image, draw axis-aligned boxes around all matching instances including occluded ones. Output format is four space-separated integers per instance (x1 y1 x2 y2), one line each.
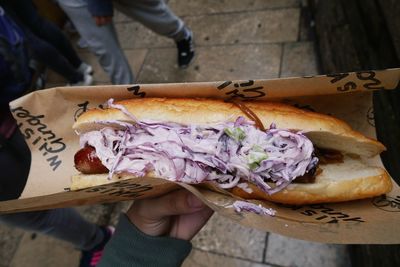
57 0 194 84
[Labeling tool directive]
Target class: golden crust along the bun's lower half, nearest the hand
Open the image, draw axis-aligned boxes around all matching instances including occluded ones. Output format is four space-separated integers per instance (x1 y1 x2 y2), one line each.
71 169 392 205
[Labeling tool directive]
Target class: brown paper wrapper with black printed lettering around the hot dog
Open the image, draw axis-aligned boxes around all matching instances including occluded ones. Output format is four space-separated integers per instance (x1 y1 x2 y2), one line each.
0 69 400 244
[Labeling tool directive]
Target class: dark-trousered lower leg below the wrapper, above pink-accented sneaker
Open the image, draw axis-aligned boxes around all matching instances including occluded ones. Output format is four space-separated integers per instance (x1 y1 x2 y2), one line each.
0 209 104 250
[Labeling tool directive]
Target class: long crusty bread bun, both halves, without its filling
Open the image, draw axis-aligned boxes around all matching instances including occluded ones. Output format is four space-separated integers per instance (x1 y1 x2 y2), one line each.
72 98 391 204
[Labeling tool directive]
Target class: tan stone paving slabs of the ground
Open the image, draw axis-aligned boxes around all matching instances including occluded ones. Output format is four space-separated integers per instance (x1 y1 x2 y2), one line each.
0 0 350 267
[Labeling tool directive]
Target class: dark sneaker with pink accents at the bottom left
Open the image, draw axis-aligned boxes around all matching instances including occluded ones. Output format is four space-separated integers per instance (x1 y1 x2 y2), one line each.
79 226 115 267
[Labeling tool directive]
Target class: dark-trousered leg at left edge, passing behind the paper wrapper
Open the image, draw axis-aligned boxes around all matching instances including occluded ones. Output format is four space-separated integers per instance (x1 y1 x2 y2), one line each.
0 128 104 249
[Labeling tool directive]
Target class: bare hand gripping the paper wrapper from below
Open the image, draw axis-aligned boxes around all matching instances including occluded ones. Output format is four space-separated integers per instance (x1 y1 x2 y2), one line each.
126 189 213 240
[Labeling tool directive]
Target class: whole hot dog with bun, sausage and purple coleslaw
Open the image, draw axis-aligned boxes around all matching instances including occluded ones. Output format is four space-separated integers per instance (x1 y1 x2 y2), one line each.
72 98 391 204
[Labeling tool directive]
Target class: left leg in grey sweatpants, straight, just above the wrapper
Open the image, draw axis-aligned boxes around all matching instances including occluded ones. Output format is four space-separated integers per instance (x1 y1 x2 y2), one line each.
58 0 134 84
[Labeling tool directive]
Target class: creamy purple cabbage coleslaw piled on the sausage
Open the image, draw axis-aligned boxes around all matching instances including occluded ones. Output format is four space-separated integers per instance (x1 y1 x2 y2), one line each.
75 99 318 194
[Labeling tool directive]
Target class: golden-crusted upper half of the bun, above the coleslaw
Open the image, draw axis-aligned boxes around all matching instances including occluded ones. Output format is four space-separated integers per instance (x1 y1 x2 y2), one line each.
73 98 385 156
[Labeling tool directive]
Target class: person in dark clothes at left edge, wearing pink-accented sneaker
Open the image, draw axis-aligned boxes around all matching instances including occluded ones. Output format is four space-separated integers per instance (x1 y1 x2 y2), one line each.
0 7 113 267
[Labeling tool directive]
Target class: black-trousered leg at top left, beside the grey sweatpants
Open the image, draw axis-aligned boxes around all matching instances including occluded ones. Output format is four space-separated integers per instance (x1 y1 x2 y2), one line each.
9 0 82 69
